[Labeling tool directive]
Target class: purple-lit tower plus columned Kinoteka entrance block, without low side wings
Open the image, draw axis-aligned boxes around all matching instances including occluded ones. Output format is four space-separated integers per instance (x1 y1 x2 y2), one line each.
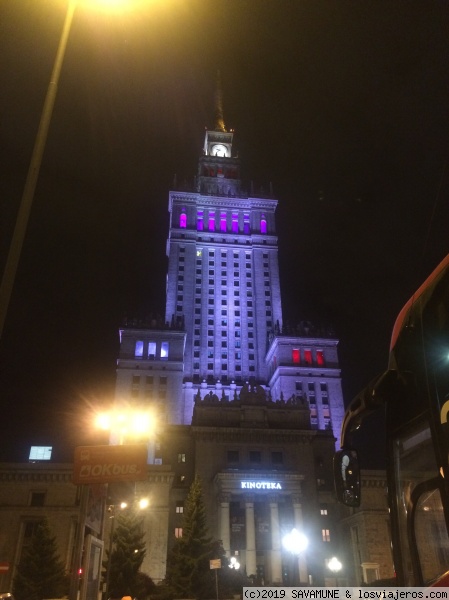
111 110 344 583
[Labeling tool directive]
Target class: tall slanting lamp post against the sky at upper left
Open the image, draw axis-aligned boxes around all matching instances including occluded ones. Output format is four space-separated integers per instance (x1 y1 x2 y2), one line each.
0 0 76 338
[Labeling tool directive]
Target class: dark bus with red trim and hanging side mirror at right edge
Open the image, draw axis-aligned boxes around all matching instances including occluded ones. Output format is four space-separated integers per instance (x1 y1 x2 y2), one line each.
334 255 449 587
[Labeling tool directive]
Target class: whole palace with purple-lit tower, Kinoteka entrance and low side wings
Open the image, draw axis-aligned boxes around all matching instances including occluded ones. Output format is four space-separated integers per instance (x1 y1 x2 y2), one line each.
0 93 391 600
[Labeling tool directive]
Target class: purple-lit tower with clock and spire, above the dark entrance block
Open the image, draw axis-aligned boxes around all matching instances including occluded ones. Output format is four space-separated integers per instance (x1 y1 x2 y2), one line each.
117 86 343 446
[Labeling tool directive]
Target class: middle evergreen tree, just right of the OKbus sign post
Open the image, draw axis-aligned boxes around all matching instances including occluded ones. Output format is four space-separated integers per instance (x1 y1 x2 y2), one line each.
104 509 148 598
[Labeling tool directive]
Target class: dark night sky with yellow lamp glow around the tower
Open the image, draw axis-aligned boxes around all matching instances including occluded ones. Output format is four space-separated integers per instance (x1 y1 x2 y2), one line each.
0 0 449 461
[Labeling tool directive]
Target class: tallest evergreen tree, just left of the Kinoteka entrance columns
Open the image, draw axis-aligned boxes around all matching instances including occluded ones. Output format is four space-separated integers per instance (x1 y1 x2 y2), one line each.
166 477 227 599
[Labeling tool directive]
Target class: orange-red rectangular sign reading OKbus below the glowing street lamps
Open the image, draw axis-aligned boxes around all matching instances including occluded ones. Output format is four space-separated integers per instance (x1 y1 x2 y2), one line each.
73 444 148 484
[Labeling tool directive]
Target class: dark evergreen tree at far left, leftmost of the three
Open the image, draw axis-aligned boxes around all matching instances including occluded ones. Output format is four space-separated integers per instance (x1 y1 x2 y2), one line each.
13 520 68 600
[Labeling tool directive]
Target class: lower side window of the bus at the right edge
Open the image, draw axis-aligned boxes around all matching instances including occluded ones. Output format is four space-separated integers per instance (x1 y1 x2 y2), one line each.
394 422 449 586
